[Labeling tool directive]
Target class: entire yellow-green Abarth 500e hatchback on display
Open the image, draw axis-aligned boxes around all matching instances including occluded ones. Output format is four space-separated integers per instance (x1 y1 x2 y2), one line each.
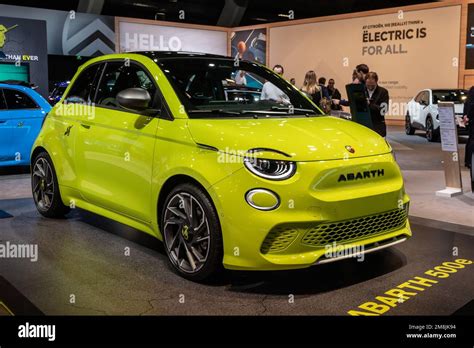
32 52 411 281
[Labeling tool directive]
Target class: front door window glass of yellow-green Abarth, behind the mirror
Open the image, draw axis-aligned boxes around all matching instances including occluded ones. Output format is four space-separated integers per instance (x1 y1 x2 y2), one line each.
95 62 157 108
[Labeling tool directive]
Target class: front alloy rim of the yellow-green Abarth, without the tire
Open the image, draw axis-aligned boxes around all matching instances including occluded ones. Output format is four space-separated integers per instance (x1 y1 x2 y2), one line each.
163 192 211 273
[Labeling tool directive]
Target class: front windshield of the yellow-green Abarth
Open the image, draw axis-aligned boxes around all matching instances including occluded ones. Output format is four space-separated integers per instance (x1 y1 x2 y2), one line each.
158 57 321 118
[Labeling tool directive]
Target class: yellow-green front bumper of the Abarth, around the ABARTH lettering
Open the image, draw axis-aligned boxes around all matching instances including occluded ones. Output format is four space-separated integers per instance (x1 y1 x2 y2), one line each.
210 154 411 270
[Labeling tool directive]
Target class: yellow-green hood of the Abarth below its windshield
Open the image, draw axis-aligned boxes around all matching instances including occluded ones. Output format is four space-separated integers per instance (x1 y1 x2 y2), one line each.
188 116 391 161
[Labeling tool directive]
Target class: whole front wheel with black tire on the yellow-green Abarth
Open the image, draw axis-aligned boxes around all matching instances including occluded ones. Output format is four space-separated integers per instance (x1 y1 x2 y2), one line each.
160 183 223 282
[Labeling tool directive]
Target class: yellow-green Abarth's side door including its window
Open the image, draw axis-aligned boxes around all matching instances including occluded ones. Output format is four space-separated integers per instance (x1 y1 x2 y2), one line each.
75 61 159 222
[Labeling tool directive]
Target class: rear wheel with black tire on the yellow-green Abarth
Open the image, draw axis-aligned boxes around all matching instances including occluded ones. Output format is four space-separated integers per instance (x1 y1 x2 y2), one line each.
31 152 70 218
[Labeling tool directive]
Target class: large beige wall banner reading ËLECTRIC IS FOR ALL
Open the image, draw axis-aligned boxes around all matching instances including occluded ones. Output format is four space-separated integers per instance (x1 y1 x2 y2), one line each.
270 5 461 118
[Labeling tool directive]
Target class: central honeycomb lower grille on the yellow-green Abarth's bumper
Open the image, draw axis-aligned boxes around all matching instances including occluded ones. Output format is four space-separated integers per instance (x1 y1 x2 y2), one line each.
301 209 407 246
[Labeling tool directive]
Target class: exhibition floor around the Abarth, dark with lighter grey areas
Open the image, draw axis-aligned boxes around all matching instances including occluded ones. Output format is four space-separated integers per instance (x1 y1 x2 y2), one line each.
0 127 474 315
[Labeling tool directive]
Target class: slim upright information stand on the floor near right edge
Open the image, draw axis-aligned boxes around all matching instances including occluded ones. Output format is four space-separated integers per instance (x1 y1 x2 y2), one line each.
436 102 462 197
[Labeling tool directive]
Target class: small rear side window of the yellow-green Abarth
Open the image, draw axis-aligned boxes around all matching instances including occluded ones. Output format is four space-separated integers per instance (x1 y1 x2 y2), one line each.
65 64 103 103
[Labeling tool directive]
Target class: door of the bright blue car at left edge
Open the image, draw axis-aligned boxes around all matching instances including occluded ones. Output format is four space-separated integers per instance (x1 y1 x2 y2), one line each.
3 88 45 164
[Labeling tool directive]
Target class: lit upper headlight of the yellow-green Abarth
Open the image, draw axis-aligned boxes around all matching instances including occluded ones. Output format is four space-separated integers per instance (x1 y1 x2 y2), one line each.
244 157 296 180
